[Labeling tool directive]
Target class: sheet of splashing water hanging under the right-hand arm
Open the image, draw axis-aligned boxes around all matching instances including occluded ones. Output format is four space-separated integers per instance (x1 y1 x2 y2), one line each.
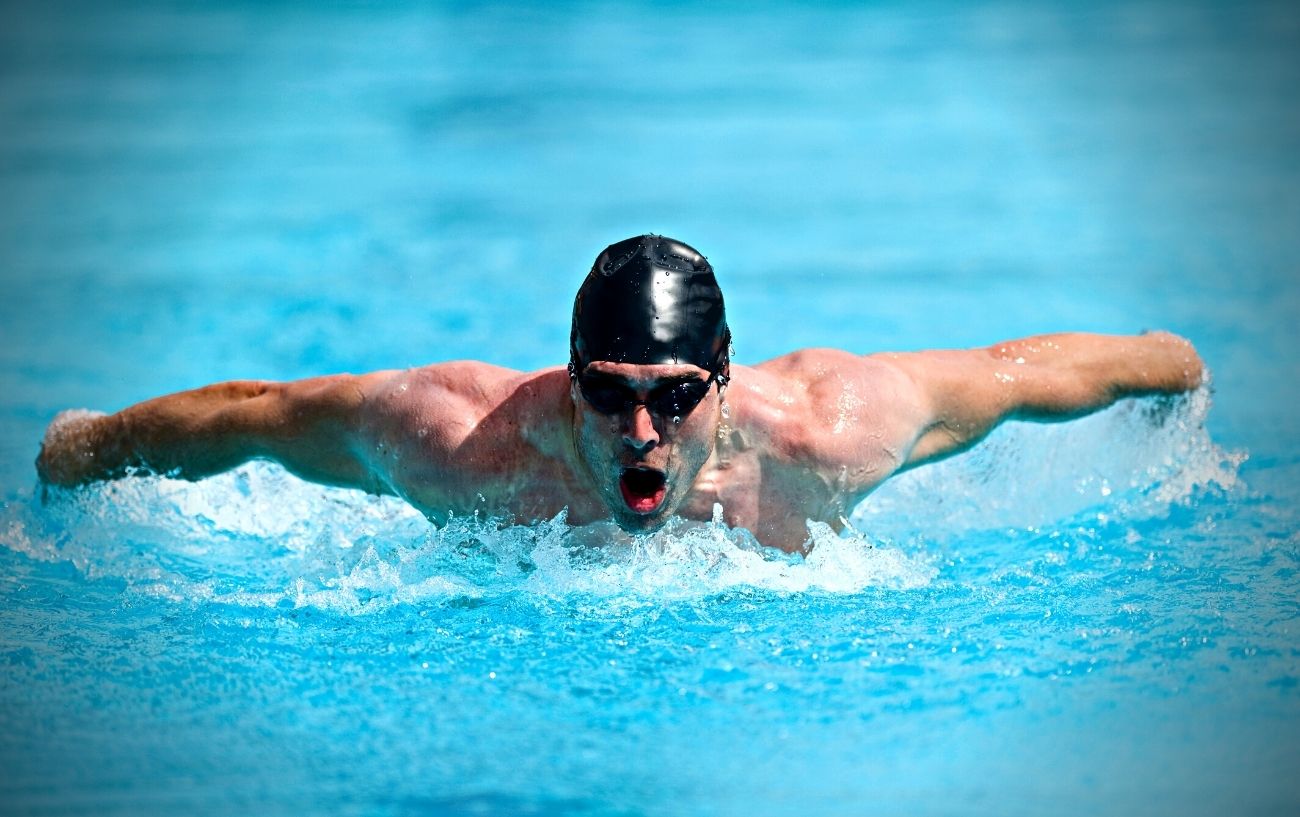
852 384 1245 540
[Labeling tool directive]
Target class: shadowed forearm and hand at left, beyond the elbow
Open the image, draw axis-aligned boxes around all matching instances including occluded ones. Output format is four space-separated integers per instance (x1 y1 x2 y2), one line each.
36 381 272 485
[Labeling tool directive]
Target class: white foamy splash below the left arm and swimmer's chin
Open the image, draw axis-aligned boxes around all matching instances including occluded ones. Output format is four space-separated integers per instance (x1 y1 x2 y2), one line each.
0 463 935 615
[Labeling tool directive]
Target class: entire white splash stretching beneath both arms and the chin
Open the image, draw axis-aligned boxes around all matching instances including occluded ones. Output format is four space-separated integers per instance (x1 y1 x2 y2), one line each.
0 389 1244 615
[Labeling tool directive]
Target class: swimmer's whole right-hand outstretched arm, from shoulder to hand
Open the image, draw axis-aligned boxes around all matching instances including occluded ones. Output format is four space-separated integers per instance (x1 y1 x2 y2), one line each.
874 332 1203 467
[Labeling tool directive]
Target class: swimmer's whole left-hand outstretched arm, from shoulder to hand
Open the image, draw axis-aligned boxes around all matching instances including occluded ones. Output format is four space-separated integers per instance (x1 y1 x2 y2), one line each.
36 373 385 492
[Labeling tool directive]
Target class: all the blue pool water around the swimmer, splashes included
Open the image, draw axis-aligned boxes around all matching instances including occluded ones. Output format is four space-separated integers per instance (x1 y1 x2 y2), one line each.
0 3 1300 816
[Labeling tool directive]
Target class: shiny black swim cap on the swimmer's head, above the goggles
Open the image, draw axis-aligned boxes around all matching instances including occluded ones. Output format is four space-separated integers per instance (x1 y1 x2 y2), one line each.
569 235 731 382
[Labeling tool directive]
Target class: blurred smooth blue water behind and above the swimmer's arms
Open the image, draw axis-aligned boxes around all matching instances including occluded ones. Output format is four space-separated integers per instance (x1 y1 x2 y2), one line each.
0 1 1300 455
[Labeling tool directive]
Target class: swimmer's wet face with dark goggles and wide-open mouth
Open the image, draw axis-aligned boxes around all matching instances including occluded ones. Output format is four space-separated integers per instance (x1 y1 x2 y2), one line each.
572 360 719 531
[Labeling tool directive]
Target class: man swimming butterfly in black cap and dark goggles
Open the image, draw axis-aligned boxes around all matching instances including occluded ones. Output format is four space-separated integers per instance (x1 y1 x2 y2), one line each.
36 235 1201 550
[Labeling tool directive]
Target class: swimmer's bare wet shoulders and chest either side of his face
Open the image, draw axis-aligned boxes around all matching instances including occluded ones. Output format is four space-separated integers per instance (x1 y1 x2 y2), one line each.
363 350 917 550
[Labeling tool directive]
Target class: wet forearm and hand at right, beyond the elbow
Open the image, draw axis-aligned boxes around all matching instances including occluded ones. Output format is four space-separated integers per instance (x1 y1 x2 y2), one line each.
987 332 1204 420
